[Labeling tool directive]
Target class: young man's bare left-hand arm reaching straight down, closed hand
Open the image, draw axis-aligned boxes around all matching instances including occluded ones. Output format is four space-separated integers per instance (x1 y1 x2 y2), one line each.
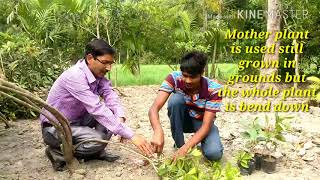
148 91 170 153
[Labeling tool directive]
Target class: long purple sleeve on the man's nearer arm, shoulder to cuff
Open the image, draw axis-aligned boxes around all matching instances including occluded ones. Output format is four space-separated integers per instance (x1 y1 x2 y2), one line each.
63 77 134 139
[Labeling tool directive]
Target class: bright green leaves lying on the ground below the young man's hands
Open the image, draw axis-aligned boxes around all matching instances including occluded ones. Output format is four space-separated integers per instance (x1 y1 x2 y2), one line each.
158 148 240 180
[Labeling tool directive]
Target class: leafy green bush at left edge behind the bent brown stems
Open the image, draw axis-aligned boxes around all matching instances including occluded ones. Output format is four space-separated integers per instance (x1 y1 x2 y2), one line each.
0 32 69 119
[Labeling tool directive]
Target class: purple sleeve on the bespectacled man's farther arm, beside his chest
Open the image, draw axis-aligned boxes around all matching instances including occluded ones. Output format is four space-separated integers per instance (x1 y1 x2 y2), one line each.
98 78 125 117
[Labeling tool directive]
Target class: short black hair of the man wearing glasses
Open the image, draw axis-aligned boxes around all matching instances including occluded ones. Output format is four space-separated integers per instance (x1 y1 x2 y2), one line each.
85 39 115 57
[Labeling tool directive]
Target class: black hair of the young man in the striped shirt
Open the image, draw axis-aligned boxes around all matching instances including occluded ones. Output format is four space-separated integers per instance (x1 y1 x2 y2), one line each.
180 51 208 75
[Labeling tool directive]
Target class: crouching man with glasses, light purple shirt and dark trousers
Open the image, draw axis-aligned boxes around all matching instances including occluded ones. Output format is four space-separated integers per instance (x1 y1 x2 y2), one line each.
40 39 153 171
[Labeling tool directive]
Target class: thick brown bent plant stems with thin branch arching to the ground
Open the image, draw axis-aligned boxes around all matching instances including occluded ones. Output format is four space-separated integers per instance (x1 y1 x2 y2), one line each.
0 78 158 174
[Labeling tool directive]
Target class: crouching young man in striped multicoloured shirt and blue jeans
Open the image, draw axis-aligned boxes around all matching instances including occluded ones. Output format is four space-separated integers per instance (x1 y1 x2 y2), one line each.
149 52 223 160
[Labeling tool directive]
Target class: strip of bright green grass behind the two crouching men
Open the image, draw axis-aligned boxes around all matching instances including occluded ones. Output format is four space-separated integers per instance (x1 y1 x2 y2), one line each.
111 64 238 86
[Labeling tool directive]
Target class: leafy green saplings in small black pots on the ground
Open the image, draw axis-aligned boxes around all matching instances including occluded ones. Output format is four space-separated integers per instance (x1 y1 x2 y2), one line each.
238 113 293 173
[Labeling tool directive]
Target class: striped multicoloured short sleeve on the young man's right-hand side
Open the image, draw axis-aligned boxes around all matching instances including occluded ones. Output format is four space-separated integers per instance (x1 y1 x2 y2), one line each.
205 82 222 112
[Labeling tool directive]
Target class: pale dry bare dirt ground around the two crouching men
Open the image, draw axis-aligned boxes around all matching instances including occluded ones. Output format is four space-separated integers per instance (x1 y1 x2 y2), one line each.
0 86 320 180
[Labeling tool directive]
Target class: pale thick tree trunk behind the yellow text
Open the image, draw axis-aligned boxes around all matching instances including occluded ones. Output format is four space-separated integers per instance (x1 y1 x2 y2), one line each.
259 0 281 88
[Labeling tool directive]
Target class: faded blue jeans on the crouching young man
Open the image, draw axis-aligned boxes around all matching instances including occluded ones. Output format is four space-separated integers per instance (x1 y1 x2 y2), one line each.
168 93 223 161
